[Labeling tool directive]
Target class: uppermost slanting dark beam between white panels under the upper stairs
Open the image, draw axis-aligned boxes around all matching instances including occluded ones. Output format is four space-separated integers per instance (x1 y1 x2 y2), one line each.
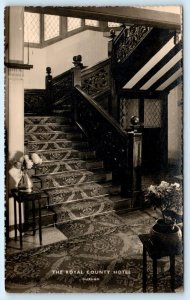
133 41 182 90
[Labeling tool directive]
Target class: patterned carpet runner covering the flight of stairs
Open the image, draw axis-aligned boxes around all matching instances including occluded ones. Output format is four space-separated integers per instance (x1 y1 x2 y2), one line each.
25 108 119 233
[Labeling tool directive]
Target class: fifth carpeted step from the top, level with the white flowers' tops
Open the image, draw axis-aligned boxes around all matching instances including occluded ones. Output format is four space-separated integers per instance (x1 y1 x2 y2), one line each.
29 148 80 162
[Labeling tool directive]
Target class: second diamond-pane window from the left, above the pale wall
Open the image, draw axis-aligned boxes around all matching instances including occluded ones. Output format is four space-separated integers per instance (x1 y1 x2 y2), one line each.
44 15 60 41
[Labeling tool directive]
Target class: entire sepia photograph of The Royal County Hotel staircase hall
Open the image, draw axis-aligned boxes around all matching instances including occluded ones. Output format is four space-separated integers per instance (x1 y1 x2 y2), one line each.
4 5 184 293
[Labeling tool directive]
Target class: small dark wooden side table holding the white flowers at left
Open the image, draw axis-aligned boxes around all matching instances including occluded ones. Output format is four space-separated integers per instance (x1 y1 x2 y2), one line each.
11 188 42 249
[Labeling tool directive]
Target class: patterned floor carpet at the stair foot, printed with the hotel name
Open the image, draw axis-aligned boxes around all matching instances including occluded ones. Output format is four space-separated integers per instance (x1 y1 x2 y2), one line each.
6 211 183 293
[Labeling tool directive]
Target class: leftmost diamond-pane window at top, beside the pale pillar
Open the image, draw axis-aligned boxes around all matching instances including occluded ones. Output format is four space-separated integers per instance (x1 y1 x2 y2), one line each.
24 12 40 44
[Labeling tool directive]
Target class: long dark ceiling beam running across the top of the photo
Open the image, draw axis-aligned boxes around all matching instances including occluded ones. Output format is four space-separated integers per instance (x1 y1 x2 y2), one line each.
25 6 181 30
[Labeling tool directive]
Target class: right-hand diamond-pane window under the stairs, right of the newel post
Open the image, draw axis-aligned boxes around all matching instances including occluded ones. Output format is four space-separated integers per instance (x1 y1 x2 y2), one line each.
144 99 161 128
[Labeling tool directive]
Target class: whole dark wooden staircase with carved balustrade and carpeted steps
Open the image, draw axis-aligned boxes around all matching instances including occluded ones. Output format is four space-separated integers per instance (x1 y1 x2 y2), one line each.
25 22 174 230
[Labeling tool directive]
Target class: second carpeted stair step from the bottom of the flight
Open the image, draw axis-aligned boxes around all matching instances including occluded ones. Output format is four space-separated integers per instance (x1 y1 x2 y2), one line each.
44 182 108 206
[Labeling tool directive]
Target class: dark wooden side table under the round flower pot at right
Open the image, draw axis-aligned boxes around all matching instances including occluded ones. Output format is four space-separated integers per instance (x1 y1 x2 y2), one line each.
139 234 182 293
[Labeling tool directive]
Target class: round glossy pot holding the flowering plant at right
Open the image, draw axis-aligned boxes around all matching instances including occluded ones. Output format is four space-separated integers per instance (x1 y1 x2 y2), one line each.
150 219 182 250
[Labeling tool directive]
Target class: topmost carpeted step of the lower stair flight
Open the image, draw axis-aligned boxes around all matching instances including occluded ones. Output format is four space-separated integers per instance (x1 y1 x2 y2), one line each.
24 116 72 126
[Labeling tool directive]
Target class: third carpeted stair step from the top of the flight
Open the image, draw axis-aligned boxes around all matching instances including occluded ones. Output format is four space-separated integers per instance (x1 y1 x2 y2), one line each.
25 131 83 142
